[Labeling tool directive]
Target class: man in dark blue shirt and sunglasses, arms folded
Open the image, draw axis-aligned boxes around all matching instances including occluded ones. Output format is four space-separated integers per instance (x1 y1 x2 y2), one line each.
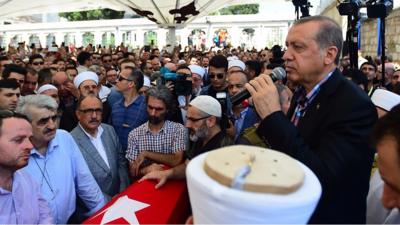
111 69 147 151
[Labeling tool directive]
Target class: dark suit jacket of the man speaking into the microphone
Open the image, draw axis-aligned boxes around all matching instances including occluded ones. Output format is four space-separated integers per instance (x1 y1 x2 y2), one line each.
257 70 377 224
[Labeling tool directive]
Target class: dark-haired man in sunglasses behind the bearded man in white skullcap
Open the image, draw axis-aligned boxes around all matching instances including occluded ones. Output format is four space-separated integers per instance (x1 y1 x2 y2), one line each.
200 55 228 98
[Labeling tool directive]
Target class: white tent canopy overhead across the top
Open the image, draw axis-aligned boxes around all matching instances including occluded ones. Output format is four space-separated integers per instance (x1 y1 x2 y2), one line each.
0 0 324 28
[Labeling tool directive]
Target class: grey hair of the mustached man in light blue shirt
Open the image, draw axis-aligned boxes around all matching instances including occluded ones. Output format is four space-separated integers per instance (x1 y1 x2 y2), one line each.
15 95 58 120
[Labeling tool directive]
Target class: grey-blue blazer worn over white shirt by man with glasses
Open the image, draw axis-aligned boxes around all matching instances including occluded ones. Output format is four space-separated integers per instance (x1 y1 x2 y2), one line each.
71 123 129 198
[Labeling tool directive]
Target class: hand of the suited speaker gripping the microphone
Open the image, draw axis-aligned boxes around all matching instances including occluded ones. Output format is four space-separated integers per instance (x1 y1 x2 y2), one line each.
245 74 281 119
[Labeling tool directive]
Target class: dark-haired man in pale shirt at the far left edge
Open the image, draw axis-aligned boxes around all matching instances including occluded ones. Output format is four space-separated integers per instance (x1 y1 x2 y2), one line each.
0 110 54 224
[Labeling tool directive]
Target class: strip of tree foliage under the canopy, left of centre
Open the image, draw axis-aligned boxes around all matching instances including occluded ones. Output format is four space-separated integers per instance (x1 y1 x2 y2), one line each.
59 9 124 21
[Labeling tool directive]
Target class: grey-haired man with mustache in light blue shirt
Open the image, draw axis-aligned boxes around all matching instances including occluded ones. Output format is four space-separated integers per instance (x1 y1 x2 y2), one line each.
16 95 105 224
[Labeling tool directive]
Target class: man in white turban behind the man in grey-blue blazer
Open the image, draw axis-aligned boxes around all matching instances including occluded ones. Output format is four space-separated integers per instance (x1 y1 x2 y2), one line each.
74 71 111 123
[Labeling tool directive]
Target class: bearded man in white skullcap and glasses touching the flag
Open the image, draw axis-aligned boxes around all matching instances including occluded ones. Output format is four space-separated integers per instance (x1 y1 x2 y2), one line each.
141 95 233 188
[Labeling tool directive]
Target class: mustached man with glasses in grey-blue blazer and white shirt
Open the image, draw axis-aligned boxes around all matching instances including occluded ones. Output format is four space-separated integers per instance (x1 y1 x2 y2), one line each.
71 95 130 223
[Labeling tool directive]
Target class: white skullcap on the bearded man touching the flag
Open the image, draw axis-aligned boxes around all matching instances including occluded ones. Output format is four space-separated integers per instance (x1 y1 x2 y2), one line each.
190 95 222 117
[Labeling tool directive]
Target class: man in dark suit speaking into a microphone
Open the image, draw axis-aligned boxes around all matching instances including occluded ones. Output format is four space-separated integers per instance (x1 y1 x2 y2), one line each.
246 16 377 224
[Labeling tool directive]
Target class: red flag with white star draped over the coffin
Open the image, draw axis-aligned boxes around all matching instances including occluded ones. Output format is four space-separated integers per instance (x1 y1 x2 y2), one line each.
84 180 190 224
